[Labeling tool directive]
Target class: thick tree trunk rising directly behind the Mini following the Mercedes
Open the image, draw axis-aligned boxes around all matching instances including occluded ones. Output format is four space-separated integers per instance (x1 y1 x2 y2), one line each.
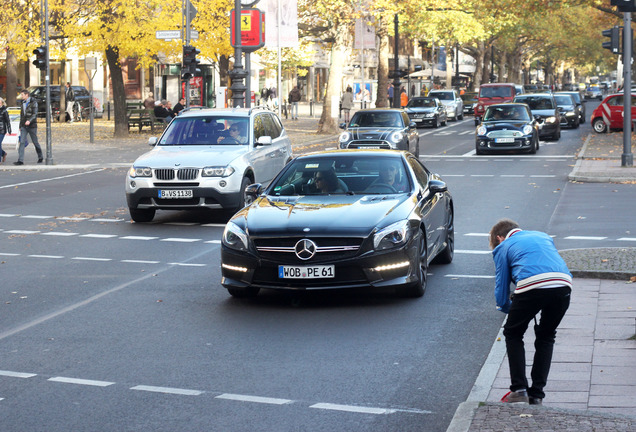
318 29 347 134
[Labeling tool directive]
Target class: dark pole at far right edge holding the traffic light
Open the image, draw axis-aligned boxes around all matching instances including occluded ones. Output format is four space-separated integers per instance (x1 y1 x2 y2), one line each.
621 12 634 167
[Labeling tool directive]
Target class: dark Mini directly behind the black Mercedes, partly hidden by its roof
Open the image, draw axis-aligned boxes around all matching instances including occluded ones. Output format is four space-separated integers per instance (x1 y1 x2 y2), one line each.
339 108 420 156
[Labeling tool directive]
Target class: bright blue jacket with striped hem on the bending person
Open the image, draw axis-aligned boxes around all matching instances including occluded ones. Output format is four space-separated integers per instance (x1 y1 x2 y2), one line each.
492 229 572 313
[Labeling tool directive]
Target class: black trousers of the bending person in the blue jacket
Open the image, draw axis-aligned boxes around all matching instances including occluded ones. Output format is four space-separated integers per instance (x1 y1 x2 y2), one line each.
503 286 572 399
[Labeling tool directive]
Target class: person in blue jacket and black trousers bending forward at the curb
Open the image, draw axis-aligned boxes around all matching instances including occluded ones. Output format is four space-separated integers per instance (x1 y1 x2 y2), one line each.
489 219 572 405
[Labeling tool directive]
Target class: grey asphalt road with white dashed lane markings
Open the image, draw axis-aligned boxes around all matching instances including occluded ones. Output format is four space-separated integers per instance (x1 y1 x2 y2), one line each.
0 107 636 431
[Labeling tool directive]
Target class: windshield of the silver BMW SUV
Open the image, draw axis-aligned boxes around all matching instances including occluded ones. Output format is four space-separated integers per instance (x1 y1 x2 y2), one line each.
159 116 250 146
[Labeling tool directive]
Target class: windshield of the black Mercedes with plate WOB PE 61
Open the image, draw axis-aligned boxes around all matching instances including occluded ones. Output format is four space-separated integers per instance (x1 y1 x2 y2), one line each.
269 154 412 196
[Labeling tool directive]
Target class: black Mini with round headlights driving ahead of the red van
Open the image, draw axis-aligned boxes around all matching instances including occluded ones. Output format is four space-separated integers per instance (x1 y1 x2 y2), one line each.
475 103 539 154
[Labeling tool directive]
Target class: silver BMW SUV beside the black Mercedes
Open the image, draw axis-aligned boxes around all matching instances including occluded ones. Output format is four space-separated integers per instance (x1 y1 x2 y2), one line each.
126 108 292 222
